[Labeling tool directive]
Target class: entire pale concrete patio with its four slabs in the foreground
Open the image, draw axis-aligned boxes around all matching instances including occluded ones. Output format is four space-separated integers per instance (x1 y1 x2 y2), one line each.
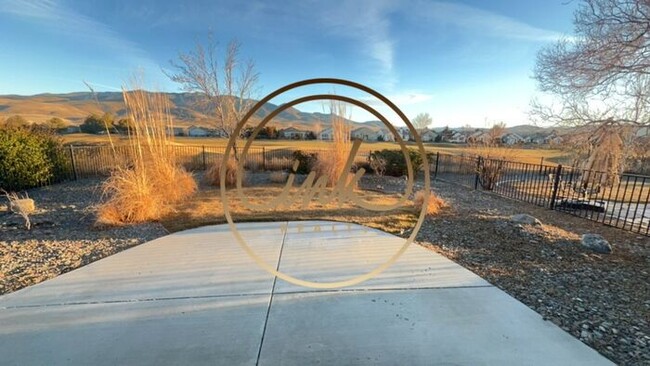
0 221 611 366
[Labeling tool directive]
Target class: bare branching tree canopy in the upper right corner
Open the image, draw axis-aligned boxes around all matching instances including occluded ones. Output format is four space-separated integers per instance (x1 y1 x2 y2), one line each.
533 0 650 126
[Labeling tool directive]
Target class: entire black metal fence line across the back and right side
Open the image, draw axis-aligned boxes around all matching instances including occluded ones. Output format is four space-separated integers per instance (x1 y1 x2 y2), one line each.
47 145 650 235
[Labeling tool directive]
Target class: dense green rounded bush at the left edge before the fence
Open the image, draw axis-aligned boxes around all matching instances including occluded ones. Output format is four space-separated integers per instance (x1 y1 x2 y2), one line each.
0 128 69 191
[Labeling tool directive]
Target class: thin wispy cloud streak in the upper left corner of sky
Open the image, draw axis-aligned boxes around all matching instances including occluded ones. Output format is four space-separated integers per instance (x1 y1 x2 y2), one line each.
0 0 155 67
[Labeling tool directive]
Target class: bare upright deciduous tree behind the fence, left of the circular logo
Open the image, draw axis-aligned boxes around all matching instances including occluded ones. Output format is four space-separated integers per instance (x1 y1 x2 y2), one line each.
165 36 259 158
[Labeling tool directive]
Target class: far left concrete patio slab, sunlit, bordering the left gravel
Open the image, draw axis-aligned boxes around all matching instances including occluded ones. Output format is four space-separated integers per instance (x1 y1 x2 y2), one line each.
0 223 284 308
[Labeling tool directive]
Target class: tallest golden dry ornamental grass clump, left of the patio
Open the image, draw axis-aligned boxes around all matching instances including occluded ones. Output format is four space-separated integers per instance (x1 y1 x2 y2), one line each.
97 81 197 225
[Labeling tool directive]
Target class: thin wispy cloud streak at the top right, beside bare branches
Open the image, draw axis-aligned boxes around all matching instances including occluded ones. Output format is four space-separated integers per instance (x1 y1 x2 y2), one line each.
408 0 568 42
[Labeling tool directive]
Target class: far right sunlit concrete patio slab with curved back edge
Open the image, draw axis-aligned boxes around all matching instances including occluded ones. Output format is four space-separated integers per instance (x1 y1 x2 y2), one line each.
274 221 491 293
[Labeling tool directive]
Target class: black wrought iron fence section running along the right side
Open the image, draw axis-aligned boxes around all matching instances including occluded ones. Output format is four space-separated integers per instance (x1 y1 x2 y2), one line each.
431 154 650 235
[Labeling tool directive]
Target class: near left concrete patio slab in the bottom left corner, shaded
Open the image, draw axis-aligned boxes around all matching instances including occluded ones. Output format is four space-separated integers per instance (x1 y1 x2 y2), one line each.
0 295 270 366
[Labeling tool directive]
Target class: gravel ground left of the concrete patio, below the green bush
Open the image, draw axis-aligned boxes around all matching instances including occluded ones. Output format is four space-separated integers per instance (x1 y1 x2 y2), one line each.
0 180 167 294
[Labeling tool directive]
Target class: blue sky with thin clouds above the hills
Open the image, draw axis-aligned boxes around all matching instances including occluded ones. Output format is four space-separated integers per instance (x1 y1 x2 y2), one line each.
0 0 575 127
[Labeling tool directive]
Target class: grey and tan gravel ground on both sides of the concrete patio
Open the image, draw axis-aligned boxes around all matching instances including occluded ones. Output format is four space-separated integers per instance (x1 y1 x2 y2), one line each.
0 177 650 365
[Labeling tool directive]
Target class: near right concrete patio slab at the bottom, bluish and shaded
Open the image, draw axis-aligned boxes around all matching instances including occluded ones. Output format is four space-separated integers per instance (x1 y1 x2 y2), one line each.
260 287 610 366
